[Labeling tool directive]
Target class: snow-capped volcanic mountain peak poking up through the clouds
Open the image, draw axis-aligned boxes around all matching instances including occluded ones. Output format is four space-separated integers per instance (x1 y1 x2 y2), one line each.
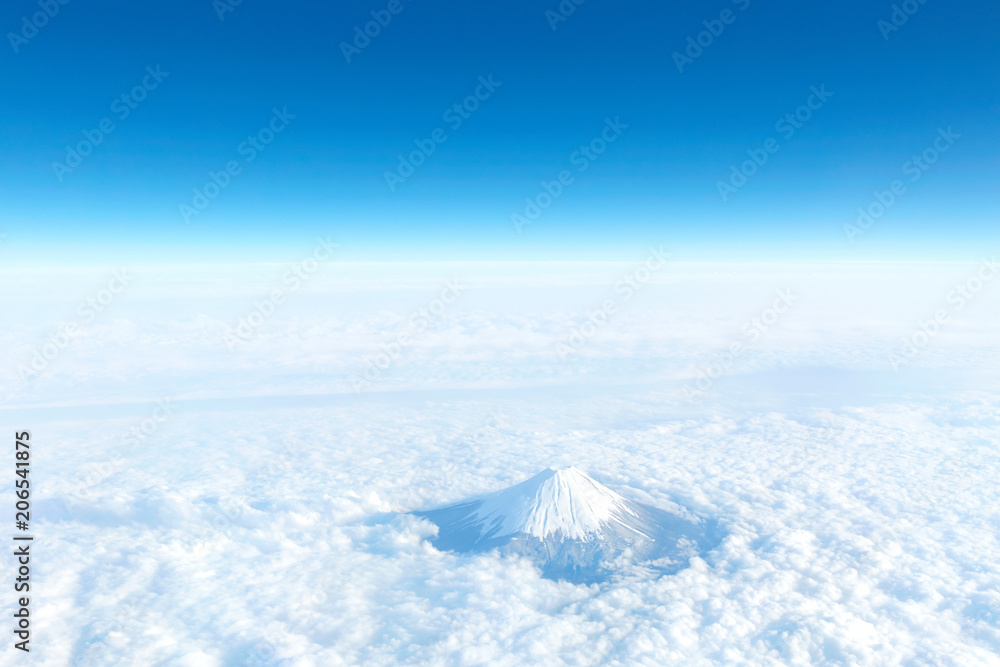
414 467 711 583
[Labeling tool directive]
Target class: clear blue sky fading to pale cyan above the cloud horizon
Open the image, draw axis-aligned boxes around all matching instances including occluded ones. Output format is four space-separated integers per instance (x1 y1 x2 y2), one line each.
0 0 1000 265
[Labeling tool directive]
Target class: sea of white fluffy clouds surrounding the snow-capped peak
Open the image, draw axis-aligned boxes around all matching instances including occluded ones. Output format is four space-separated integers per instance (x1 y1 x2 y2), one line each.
0 258 1000 666
